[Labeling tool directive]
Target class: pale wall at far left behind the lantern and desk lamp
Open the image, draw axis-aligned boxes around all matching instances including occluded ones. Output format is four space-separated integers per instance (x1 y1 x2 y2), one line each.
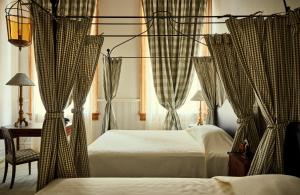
0 0 29 161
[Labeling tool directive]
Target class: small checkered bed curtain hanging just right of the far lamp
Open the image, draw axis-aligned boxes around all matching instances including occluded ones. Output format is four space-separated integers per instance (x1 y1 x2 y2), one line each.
194 57 217 125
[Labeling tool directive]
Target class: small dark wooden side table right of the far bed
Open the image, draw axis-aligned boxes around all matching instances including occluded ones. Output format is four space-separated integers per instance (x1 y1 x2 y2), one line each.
228 152 252 176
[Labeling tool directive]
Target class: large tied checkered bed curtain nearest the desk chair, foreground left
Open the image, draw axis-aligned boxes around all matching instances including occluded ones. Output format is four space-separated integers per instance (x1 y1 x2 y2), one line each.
32 4 91 190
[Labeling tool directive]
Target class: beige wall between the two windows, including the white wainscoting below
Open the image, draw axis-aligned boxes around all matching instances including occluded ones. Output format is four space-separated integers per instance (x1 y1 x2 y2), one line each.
93 0 144 135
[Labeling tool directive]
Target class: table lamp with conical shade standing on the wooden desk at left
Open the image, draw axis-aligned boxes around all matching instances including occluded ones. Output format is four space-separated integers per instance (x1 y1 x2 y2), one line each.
6 73 34 127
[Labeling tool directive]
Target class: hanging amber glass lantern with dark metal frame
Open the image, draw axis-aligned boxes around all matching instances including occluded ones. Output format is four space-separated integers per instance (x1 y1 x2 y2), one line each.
5 0 32 49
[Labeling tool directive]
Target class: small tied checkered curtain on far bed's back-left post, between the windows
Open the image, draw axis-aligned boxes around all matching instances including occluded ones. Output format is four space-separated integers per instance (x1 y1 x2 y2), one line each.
102 57 122 133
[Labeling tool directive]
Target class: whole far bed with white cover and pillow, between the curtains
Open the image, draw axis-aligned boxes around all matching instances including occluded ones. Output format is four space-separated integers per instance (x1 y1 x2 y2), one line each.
88 125 232 178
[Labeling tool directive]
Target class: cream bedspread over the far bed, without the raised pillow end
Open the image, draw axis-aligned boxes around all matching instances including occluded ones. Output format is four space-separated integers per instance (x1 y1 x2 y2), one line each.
88 130 206 177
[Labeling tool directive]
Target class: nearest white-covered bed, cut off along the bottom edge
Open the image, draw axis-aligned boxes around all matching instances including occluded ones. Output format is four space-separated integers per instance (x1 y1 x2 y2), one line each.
37 175 300 195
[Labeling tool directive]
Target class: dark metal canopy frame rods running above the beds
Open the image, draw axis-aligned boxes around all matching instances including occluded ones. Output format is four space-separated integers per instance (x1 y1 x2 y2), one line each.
30 0 291 59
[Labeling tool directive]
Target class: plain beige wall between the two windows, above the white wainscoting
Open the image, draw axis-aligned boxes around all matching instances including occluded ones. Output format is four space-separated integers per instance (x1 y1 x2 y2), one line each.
99 0 140 99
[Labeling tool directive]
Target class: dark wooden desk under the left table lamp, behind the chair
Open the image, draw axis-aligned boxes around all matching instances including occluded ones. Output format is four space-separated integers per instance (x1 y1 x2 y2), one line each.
0 123 72 150
